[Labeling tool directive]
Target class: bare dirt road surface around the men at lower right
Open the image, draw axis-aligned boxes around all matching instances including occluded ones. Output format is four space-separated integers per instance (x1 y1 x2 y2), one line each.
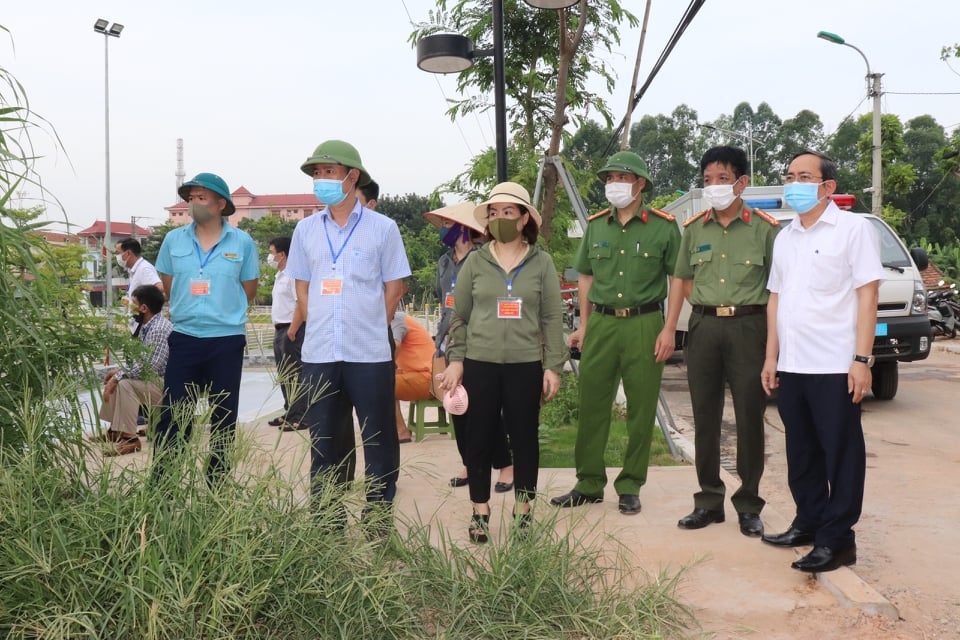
664 340 960 640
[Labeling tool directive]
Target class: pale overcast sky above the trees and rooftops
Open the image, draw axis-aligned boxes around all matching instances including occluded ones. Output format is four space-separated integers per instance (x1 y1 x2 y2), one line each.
0 0 960 228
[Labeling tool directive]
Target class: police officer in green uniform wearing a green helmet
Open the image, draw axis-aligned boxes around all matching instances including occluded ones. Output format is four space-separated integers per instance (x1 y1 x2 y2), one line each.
550 151 680 515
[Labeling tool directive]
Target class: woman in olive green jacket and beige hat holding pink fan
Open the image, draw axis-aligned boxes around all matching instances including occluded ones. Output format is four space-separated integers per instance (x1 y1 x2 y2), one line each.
440 182 567 542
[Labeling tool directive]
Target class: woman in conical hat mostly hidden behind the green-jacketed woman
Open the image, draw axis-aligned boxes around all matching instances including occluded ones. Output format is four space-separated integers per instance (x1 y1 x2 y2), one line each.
423 202 513 493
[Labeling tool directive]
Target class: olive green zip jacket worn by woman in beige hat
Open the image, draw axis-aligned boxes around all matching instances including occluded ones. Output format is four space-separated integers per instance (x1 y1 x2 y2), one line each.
447 243 568 373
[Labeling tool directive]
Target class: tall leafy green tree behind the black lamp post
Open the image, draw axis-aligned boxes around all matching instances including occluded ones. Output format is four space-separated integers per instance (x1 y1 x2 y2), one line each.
410 0 637 244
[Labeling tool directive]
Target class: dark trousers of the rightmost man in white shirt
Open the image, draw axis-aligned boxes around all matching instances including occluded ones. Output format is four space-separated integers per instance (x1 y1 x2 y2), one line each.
777 373 867 549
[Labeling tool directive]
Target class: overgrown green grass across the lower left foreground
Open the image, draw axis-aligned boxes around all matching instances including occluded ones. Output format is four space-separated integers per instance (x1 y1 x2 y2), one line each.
0 402 691 640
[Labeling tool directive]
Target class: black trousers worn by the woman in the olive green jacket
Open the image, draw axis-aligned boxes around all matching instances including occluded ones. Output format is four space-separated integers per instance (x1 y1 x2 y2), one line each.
457 359 543 503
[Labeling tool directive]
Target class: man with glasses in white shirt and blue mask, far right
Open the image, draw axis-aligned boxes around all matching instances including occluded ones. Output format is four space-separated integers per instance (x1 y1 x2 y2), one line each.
760 151 884 573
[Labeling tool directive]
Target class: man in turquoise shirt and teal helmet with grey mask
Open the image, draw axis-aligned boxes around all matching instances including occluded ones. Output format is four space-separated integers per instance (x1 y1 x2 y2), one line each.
153 173 260 485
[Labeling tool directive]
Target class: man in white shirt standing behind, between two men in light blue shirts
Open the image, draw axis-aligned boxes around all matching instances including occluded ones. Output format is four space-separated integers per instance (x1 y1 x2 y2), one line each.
267 236 308 431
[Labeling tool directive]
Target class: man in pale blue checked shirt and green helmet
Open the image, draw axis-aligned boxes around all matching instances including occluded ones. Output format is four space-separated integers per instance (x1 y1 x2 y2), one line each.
287 140 410 528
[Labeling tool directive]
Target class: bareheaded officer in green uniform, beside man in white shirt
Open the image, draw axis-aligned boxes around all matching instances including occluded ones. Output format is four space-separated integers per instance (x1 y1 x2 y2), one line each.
666 146 779 537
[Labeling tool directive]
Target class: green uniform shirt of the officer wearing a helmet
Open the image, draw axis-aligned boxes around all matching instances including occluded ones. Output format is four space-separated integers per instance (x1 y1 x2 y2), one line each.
573 208 680 308
